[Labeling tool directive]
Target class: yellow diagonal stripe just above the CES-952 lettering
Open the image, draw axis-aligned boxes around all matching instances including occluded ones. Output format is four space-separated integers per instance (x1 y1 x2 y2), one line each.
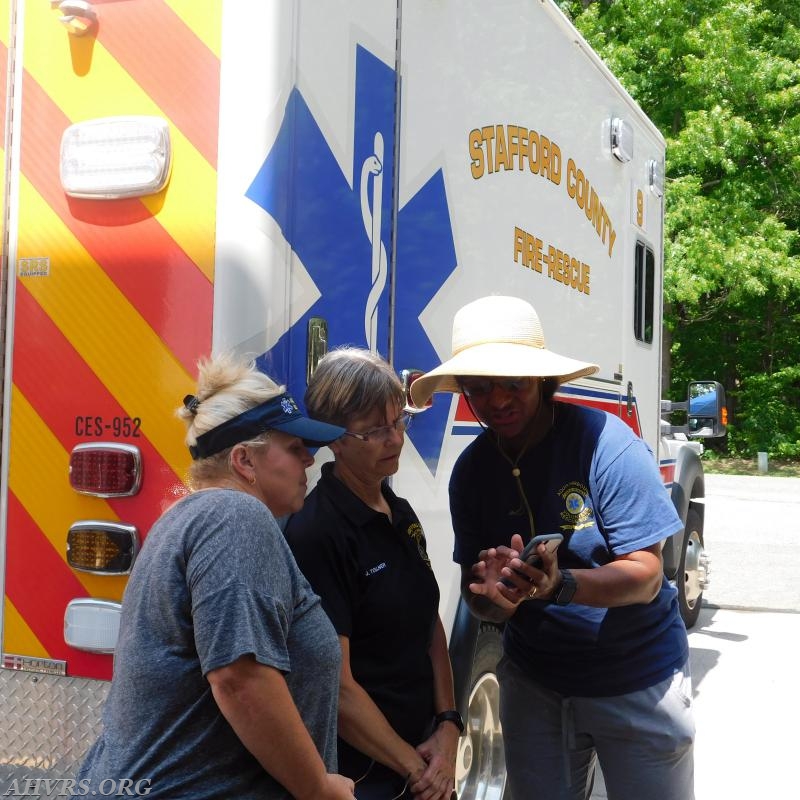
19 177 193 475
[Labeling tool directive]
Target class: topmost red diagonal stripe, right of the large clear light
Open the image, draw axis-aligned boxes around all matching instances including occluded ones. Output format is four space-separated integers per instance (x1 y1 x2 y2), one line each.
97 0 219 169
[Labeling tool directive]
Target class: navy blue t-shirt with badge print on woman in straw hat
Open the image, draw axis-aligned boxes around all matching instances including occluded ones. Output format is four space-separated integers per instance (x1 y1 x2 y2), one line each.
450 403 689 697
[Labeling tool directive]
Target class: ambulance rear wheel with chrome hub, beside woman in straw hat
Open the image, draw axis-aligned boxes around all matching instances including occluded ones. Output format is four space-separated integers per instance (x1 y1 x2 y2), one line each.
456 623 511 800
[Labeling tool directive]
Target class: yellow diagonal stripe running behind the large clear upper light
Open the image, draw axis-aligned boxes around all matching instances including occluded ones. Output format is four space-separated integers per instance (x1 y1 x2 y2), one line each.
24 3 216 280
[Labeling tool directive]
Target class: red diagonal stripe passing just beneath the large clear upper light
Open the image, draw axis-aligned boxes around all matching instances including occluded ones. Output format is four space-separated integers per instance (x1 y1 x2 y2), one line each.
21 65 213 374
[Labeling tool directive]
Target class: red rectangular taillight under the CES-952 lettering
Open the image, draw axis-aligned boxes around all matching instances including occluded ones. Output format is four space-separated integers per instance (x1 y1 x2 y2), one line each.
69 442 142 497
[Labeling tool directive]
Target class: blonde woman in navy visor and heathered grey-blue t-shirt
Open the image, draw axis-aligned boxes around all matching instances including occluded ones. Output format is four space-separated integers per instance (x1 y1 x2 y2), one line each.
77 357 353 800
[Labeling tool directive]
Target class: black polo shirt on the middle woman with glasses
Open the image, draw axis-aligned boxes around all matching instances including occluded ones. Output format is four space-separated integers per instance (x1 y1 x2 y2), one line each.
285 463 439 778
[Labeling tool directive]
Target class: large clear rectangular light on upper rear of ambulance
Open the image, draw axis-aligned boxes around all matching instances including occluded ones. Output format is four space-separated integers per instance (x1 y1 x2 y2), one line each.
61 117 172 200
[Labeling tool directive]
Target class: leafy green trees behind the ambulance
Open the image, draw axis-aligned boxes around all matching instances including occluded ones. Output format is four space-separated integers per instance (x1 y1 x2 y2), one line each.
560 0 800 456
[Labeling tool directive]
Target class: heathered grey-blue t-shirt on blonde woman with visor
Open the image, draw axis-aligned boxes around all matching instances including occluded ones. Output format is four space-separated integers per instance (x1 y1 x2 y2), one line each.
77 489 341 800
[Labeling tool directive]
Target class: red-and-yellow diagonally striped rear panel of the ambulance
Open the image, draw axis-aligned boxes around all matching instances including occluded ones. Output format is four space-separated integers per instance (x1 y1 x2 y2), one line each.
0 0 222 684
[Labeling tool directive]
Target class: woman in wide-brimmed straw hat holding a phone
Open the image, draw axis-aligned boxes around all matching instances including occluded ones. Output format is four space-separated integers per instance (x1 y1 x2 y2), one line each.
411 297 694 800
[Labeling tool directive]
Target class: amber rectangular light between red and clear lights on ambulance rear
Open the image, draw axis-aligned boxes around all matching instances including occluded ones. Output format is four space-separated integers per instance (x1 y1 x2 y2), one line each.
67 520 139 575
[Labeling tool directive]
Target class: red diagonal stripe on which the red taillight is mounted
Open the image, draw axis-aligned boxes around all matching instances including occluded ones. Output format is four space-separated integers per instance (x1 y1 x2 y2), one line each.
14 281 188 538
